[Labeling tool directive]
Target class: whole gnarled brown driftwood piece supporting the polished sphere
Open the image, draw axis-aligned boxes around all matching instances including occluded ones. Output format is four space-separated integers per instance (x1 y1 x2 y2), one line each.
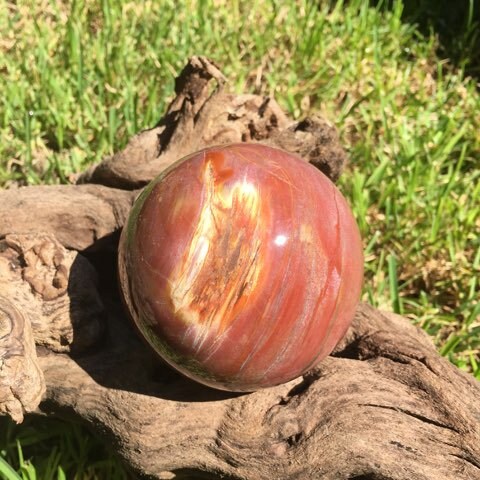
0 57 480 480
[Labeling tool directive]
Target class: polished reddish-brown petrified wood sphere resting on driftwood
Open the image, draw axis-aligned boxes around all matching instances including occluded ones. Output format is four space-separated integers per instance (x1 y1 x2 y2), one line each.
119 144 363 391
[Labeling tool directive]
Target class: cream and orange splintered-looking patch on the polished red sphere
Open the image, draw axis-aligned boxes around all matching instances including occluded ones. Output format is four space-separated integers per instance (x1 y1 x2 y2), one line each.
169 159 261 348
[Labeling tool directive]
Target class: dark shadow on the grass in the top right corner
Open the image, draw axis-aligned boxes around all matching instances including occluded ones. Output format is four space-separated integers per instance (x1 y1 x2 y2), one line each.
370 0 480 78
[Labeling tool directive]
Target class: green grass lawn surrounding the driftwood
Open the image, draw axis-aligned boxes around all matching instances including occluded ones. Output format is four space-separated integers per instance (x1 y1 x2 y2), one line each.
0 0 480 479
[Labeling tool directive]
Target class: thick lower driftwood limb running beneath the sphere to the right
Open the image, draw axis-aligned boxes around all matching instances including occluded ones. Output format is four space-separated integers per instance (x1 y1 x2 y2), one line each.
37 305 480 480
